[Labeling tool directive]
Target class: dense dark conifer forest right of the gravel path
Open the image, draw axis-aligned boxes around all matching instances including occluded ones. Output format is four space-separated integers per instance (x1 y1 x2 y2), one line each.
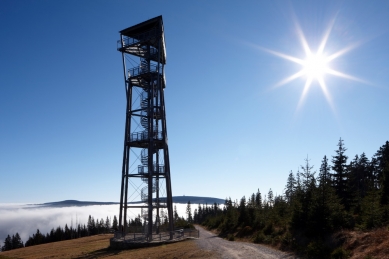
193 139 389 258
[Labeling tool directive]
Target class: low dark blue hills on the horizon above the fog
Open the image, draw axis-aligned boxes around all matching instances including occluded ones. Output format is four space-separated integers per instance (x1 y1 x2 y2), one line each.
33 196 224 207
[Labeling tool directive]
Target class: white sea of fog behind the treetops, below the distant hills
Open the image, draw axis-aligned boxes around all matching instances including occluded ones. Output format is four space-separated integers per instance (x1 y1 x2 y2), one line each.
0 203 194 246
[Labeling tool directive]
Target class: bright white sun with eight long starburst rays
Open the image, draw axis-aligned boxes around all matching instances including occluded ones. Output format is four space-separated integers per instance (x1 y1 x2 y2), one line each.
256 19 365 110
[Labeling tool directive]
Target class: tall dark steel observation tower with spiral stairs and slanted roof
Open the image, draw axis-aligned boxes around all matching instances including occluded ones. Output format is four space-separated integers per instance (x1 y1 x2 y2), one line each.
117 16 174 242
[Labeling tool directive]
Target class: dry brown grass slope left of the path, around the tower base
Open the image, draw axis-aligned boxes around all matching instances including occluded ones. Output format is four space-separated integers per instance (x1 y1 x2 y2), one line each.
0 235 218 259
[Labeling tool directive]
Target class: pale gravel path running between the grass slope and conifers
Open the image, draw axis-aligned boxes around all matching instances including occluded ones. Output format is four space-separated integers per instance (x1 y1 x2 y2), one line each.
196 226 298 259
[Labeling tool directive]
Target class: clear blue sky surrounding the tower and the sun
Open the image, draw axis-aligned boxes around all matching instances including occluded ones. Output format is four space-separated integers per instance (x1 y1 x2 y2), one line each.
0 0 389 203
